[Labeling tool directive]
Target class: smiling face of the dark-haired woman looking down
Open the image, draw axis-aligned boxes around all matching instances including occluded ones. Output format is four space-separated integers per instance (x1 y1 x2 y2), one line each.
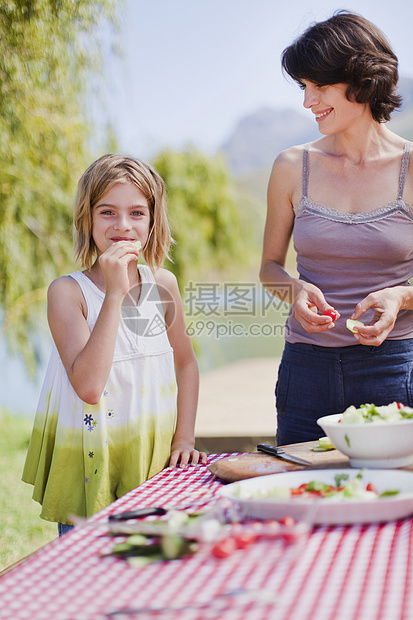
303 80 372 135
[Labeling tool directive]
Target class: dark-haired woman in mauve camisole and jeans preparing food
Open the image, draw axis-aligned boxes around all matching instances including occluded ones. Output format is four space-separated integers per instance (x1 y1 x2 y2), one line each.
260 12 413 444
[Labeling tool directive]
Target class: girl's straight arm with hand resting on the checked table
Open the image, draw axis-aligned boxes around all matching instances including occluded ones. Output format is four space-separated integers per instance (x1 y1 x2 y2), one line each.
155 269 207 467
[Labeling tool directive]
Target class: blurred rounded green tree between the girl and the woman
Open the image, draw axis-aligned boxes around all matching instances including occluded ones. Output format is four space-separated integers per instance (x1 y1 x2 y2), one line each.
153 147 249 287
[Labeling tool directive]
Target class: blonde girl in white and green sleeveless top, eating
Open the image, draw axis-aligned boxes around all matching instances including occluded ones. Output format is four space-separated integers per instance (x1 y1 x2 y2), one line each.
23 155 206 534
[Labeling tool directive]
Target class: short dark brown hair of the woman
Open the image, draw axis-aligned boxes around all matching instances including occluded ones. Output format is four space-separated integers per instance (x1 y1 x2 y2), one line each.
281 11 402 123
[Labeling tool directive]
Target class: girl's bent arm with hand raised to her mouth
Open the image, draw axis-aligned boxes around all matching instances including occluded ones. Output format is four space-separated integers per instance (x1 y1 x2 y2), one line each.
47 242 138 405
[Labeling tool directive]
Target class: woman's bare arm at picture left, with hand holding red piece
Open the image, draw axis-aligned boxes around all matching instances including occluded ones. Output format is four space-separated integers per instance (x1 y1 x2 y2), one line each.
260 147 334 332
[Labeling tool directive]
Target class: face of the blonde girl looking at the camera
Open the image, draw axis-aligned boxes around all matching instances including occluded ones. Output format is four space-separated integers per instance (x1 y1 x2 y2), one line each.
92 183 151 256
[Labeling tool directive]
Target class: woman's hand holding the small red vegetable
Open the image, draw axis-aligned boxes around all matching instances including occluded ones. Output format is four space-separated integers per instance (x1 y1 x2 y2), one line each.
294 280 340 332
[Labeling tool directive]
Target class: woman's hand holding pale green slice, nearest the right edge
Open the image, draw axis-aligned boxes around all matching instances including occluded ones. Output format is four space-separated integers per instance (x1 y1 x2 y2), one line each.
351 286 406 346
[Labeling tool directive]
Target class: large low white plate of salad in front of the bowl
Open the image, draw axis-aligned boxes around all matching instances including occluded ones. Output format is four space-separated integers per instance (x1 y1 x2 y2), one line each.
220 469 413 524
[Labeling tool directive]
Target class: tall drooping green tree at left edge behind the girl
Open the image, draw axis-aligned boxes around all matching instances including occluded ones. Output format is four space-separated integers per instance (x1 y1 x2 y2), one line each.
0 0 118 368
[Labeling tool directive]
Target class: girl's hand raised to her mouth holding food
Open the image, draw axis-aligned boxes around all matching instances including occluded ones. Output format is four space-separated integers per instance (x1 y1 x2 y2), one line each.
99 241 139 297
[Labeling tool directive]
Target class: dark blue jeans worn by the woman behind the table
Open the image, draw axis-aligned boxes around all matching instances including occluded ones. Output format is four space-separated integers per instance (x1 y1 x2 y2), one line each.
275 339 413 445
